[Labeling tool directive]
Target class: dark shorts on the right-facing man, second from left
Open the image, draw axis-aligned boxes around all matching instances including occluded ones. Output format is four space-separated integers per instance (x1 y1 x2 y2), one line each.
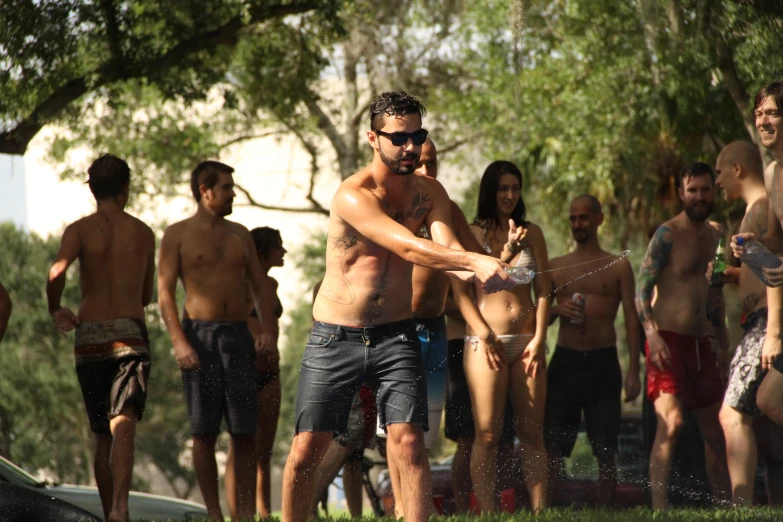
182 319 258 435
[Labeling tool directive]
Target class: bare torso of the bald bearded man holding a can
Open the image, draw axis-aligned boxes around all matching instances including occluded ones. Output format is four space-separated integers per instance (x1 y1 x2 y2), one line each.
551 250 629 350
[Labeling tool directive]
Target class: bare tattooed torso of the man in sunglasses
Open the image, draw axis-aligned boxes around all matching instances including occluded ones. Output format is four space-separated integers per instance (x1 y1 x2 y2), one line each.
313 167 445 326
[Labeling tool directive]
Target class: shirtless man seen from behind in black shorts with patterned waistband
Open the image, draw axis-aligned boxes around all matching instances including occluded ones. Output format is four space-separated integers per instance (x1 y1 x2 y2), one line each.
46 154 155 522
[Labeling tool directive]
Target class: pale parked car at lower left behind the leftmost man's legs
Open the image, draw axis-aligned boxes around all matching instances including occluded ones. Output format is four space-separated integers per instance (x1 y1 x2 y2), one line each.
0 457 208 520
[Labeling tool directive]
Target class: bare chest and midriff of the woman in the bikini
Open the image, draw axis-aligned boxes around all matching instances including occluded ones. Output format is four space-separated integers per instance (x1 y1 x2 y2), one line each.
468 219 543 335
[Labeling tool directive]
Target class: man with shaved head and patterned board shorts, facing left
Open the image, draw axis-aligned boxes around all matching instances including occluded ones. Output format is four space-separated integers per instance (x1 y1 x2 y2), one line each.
708 141 783 505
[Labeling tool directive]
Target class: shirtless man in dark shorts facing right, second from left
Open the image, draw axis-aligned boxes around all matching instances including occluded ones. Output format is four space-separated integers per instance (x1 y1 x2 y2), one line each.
158 161 277 520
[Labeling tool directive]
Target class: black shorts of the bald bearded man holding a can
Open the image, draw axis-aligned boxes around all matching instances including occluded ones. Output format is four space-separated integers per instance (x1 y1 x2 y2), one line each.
544 345 623 458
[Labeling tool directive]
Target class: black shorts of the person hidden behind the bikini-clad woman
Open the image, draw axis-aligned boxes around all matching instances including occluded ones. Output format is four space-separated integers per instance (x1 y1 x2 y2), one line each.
445 339 514 442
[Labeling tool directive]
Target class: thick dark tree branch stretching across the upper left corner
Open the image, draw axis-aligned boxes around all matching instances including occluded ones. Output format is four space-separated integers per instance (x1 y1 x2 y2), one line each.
0 0 317 155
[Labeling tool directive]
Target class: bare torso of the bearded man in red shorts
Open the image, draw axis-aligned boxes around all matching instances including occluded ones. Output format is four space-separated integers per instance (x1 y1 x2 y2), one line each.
653 212 720 337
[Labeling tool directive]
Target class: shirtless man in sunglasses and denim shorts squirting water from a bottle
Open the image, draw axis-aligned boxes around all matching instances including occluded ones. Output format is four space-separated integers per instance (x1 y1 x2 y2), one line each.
283 92 512 522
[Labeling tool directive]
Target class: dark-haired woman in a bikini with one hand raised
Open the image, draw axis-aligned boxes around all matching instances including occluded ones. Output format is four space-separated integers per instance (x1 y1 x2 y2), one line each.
454 161 552 511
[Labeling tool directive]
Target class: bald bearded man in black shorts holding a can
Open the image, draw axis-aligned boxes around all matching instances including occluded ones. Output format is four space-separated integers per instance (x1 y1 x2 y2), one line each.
544 195 641 506
